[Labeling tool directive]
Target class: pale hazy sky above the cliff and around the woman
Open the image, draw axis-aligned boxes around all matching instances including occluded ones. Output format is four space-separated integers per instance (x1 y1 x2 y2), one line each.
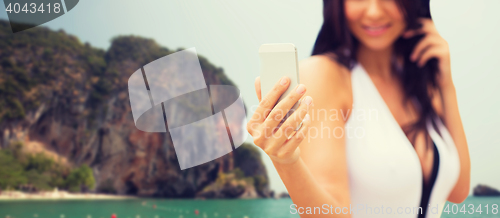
0 0 500 193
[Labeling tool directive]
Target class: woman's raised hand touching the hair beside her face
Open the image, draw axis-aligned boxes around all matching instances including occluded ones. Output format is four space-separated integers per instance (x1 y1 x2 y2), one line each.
403 18 452 88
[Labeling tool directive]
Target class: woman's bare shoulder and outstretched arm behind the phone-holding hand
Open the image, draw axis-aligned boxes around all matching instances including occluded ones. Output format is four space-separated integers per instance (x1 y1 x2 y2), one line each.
249 56 352 217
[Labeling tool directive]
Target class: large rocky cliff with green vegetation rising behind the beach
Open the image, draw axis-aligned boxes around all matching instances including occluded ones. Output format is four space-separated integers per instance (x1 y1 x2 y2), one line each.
0 21 269 198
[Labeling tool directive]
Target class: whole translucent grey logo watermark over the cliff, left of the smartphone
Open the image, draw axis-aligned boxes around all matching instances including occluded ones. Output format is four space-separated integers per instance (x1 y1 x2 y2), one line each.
128 48 247 170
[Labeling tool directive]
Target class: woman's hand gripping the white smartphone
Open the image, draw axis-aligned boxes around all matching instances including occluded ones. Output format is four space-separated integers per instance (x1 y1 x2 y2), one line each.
247 77 312 164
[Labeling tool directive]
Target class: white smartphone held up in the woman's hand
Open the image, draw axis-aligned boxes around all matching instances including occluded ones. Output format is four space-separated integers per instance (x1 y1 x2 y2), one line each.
259 43 299 112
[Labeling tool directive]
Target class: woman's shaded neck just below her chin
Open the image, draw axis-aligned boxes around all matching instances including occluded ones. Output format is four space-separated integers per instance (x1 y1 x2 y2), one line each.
357 45 392 80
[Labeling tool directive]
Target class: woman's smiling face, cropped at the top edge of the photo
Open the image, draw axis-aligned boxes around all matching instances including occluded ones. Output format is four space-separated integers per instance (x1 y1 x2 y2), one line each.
344 0 406 50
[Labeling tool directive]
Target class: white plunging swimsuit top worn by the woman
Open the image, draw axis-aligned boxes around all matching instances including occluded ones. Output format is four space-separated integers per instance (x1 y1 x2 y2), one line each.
345 64 460 218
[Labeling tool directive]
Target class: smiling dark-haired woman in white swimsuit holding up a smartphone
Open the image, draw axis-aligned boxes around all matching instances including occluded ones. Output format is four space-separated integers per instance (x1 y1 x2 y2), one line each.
247 0 470 217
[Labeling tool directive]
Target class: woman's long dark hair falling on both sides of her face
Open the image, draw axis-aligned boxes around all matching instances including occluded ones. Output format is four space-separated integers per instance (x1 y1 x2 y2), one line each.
312 0 439 146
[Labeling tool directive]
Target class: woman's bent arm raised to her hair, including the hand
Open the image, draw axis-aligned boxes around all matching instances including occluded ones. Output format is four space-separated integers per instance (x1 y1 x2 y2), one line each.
403 19 470 203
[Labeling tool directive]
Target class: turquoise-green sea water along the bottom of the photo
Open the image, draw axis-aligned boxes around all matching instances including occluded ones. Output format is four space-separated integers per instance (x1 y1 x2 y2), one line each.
0 197 500 218
